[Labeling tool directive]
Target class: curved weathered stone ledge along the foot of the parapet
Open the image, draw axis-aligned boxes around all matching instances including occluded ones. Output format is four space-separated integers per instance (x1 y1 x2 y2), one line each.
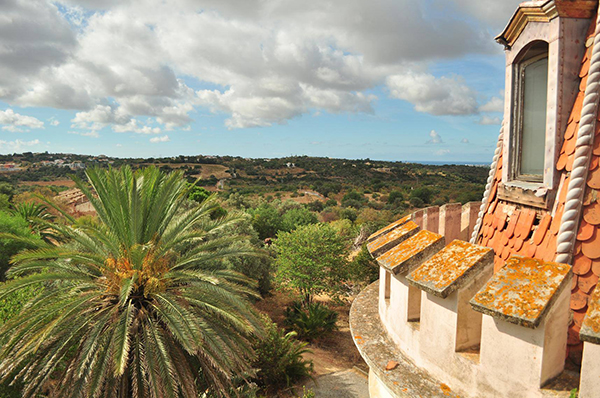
350 282 459 398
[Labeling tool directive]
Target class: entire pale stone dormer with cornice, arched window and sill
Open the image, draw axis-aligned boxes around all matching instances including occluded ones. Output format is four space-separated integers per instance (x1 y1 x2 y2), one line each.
496 0 598 210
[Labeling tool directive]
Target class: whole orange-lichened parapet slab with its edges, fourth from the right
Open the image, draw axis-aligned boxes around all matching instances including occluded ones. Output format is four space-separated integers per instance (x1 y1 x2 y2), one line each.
377 229 444 274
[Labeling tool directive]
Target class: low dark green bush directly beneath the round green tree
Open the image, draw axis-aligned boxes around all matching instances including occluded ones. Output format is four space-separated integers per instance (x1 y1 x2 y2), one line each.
284 301 338 341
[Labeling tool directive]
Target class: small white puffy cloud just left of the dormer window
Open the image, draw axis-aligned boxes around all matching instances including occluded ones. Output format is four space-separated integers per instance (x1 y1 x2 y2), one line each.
386 71 477 115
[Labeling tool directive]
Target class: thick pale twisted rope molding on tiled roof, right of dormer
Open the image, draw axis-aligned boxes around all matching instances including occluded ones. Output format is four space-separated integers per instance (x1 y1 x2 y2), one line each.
555 13 600 263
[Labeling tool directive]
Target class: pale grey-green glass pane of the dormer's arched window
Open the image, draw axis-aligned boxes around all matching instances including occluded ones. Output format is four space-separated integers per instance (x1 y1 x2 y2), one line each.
520 58 548 175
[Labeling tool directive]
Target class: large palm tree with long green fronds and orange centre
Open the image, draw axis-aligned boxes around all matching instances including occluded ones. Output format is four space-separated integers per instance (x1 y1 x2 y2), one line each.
0 167 261 398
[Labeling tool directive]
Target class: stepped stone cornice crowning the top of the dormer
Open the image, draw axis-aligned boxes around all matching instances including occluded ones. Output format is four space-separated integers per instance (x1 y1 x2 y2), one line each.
496 0 598 47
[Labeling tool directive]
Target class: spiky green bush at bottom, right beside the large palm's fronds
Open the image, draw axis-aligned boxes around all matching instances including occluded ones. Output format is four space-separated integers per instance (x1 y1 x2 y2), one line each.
252 317 313 390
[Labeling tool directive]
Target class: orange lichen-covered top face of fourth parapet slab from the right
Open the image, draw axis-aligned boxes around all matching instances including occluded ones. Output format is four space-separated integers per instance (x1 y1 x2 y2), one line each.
377 230 444 273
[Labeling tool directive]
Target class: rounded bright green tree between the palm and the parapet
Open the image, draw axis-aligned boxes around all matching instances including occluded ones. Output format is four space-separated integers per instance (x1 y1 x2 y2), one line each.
275 224 348 304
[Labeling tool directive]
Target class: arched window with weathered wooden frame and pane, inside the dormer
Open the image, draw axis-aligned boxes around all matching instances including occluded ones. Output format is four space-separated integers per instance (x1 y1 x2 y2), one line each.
512 42 548 182
